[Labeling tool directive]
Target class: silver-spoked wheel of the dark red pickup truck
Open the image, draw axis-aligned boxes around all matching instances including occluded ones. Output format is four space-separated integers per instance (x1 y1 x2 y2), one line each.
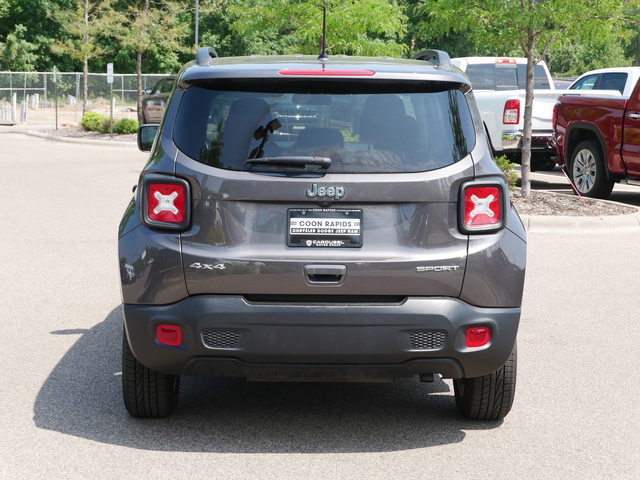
569 140 613 198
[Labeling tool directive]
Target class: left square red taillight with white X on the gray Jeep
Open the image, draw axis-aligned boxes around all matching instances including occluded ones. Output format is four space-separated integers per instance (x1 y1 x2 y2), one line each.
140 175 191 230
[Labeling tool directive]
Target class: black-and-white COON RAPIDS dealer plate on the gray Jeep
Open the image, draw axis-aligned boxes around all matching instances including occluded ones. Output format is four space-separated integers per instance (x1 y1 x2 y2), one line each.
287 208 362 248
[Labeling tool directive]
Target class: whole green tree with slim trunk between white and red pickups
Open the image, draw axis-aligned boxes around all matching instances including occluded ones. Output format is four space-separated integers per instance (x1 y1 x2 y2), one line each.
422 0 637 198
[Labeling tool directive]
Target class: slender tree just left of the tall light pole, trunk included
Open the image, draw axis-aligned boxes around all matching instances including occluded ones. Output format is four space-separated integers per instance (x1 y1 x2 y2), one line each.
114 0 191 121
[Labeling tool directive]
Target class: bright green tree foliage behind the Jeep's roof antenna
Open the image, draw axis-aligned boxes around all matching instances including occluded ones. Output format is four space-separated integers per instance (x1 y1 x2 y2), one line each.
228 0 406 56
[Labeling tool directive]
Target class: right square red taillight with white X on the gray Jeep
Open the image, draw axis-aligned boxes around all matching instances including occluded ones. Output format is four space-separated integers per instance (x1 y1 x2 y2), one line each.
459 183 505 233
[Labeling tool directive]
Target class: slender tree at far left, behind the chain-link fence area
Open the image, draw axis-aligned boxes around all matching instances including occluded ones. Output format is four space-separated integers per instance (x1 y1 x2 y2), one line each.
51 0 114 112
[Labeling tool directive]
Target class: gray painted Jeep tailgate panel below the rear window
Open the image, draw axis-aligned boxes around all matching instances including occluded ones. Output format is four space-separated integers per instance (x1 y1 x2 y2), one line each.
181 158 473 296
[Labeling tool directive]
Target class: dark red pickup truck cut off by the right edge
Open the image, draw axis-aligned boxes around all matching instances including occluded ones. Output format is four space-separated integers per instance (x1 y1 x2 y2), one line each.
553 80 640 198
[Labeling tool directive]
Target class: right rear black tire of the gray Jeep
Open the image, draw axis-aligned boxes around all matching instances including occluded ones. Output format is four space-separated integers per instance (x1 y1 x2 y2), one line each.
453 345 517 420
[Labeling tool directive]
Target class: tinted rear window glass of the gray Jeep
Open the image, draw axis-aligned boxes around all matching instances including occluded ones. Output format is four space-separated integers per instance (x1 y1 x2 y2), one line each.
173 82 475 173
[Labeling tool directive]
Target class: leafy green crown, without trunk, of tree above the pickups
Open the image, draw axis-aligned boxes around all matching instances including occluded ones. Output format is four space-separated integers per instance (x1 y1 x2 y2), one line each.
416 0 638 67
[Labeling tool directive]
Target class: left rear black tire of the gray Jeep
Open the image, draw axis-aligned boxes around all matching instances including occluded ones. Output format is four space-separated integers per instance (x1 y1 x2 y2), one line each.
122 332 180 418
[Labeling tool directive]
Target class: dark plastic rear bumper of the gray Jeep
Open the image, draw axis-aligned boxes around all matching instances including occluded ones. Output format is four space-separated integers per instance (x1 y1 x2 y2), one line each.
123 296 520 379
